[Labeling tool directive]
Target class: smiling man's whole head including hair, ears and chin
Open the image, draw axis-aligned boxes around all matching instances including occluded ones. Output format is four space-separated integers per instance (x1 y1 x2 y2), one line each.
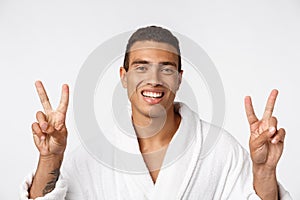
120 26 182 122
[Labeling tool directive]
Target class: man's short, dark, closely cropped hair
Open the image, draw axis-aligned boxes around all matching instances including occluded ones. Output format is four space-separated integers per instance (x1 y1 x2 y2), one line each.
123 26 181 71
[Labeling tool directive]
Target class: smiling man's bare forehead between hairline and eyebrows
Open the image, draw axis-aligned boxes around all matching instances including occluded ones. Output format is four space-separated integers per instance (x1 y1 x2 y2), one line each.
129 41 178 64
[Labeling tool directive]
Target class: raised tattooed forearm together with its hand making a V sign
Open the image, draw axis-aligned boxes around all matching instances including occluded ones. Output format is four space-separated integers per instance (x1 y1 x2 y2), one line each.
29 81 69 198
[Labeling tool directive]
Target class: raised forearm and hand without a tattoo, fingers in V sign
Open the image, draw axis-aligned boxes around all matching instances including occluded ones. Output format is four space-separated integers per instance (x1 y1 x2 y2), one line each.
245 90 285 200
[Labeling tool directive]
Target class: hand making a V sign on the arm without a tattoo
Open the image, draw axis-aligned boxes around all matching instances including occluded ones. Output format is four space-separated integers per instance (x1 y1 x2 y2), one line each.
245 90 285 170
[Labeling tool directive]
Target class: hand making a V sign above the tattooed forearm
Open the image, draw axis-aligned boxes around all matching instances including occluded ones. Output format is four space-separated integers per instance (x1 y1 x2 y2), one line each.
32 81 69 157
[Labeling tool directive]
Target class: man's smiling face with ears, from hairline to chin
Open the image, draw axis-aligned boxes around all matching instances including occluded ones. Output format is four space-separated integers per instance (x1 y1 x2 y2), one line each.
120 41 182 117
